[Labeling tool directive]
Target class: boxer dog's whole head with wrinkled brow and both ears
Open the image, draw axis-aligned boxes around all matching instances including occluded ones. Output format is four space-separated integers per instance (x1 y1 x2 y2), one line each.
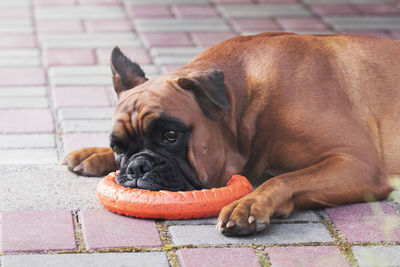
110 48 231 191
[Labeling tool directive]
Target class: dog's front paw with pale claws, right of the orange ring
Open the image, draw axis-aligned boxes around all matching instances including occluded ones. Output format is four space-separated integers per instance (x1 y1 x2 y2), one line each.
217 193 273 236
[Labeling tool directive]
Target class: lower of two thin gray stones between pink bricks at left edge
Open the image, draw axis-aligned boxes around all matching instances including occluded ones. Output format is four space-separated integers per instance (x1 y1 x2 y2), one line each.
0 96 49 109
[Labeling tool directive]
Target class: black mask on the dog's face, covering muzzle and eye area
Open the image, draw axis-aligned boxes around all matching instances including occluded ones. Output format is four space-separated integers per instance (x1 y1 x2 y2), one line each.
110 117 205 191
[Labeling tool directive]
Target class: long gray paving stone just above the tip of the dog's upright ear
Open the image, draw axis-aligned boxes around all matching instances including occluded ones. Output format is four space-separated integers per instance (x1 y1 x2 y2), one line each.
38 32 140 48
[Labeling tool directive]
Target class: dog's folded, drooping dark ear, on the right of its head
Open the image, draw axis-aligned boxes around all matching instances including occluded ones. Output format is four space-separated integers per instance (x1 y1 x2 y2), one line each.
177 69 231 121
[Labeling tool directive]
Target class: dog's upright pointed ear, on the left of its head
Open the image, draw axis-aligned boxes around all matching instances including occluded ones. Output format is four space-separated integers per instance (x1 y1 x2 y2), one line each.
111 46 148 96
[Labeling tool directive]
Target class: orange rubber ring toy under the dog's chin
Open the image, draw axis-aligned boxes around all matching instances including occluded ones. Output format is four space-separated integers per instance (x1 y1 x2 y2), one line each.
97 172 253 220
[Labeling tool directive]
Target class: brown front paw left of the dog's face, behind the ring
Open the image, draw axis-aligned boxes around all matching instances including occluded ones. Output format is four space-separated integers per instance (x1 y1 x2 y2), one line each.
62 147 117 176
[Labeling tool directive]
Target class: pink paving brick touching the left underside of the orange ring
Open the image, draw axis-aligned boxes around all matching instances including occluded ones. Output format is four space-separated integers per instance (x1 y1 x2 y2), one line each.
79 209 162 250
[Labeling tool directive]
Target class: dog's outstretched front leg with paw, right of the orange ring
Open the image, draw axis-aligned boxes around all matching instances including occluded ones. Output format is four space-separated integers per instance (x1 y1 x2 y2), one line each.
217 155 392 235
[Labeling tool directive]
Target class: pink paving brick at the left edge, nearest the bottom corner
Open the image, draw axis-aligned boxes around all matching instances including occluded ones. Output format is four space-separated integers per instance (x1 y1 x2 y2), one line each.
1 211 77 253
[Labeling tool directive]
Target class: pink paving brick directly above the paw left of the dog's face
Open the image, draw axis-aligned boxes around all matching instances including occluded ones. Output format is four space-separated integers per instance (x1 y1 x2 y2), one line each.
61 133 110 153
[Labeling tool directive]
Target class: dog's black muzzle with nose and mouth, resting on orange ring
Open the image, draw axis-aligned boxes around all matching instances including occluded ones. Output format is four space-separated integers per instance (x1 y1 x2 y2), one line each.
115 150 205 191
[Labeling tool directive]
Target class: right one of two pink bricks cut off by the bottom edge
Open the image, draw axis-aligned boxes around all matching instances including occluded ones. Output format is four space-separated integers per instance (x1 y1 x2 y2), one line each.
265 246 350 267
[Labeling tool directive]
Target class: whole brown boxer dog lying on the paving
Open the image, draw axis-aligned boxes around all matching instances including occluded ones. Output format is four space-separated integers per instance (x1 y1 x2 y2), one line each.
65 33 400 235
